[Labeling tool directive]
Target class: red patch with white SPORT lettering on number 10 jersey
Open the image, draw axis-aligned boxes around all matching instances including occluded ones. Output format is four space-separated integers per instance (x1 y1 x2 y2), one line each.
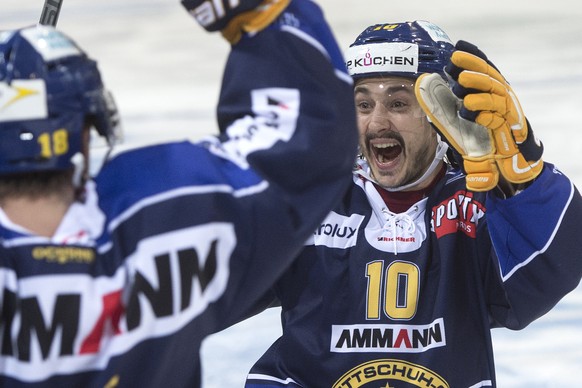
431 191 485 238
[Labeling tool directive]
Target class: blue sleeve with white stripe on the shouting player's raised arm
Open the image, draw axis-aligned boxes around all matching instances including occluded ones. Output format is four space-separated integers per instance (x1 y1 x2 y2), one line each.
487 163 582 329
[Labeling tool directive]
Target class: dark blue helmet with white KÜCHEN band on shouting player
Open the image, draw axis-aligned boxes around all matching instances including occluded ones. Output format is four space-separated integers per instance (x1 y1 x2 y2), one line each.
345 20 454 79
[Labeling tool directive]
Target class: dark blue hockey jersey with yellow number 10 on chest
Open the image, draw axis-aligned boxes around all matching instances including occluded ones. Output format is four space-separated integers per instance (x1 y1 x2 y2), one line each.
246 158 582 388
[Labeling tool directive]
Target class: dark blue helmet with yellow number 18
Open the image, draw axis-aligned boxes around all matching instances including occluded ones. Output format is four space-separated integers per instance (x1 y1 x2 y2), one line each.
0 26 120 175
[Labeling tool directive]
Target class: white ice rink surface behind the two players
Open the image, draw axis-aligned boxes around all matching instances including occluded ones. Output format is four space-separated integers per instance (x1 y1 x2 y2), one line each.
0 0 582 388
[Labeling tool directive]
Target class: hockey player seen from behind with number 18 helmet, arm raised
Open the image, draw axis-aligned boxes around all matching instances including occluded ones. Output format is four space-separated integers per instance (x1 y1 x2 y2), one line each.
0 0 357 387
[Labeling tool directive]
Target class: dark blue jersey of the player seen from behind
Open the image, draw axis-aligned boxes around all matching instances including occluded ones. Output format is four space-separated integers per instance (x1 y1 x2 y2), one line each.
0 1 357 388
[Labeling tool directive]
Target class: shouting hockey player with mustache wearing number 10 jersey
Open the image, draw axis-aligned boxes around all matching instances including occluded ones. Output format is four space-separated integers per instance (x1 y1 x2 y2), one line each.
246 21 582 388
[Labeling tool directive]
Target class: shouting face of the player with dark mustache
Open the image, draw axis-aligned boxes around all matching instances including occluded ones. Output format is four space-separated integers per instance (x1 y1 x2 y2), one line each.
354 77 437 189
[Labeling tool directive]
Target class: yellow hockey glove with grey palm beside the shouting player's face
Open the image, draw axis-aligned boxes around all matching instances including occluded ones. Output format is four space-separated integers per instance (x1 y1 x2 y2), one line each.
417 41 543 191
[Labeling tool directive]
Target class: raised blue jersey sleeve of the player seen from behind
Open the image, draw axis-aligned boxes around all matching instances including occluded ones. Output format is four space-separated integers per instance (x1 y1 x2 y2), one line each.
189 1 357 330
